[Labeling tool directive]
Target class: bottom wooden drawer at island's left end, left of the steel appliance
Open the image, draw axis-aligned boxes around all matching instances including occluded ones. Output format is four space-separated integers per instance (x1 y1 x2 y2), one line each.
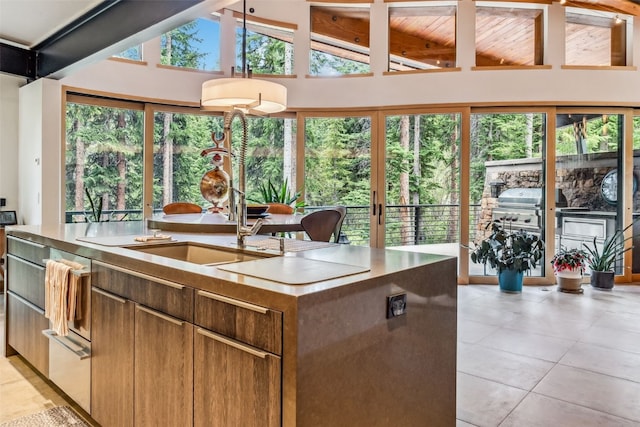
6 292 49 377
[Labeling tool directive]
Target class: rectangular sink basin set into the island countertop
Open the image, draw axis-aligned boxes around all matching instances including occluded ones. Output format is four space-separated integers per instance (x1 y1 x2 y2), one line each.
127 242 270 265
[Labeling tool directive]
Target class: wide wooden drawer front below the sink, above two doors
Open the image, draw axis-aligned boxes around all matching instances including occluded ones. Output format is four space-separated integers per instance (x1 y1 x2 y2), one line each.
91 261 193 322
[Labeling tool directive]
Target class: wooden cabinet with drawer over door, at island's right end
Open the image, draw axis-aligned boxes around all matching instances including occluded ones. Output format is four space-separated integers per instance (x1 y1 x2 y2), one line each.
194 291 282 426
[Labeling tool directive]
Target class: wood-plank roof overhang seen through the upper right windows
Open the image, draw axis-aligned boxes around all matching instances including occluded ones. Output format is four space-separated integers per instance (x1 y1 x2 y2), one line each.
311 0 640 70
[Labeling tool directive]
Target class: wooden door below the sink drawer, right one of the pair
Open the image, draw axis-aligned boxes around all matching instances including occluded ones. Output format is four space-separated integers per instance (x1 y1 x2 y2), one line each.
134 305 193 426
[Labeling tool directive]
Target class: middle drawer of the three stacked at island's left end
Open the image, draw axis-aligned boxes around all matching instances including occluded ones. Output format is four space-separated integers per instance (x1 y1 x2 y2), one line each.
7 255 45 309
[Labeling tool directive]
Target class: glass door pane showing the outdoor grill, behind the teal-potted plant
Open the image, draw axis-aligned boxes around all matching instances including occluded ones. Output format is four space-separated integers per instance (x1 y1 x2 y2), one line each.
469 111 546 277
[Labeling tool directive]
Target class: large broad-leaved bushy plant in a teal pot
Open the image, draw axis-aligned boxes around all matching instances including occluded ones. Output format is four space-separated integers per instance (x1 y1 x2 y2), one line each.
471 220 544 292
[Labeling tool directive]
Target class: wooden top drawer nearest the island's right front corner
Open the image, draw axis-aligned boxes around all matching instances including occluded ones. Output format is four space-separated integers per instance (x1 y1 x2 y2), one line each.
195 291 282 355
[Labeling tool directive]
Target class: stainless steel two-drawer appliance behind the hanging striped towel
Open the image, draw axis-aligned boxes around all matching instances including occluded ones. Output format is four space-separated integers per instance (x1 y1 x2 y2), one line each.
42 249 91 412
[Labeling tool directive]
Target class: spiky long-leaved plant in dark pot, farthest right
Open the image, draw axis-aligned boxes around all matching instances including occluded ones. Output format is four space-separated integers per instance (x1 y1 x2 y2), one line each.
582 221 635 290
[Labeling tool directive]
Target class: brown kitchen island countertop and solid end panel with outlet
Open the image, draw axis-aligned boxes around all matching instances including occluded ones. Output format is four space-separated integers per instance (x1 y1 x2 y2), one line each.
7 222 457 427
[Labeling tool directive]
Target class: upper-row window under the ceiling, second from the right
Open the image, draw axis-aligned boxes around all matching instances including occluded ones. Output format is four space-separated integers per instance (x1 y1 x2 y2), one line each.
476 6 543 67
